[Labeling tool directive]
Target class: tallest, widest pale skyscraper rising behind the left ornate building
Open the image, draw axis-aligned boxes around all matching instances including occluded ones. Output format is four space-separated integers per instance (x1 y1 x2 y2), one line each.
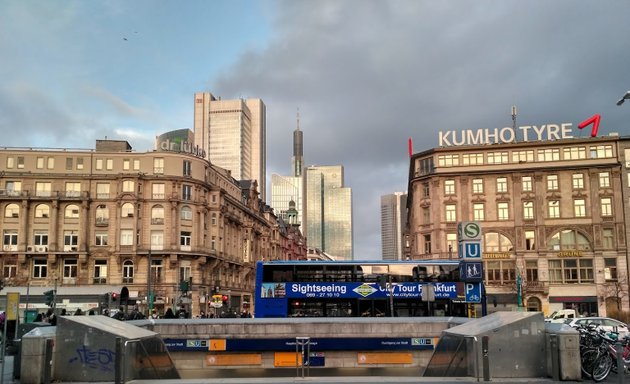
193 92 267 201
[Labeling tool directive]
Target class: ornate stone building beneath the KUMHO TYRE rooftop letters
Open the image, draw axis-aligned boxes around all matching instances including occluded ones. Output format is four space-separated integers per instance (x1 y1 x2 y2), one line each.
407 136 630 316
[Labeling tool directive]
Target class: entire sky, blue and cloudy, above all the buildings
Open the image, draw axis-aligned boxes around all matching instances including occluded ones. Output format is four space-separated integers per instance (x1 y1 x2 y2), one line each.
0 0 630 259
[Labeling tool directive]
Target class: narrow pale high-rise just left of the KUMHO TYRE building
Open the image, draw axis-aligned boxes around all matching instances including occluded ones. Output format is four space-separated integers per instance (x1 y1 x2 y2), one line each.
381 192 407 260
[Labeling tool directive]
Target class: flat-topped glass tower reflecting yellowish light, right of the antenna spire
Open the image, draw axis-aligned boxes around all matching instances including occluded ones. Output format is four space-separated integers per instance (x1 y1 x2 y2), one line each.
304 165 354 260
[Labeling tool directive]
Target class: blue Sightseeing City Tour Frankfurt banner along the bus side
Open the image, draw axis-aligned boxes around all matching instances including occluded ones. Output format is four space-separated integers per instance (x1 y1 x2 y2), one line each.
257 282 457 305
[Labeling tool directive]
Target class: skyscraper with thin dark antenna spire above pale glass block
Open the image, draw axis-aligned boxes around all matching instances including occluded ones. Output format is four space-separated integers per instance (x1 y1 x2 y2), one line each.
271 113 304 224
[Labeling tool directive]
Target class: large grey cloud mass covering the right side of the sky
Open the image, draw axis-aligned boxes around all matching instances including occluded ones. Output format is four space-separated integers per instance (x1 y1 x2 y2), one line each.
214 0 630 258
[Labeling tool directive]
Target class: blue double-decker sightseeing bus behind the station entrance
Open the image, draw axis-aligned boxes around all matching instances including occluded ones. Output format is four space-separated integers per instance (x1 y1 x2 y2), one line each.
254 260 467 318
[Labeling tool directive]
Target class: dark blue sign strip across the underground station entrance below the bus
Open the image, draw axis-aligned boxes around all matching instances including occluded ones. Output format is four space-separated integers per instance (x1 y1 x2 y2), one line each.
164 337 434 352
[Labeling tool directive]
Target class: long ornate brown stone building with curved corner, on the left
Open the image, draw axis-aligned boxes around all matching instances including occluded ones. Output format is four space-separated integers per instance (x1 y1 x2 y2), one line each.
0 140 306 316
